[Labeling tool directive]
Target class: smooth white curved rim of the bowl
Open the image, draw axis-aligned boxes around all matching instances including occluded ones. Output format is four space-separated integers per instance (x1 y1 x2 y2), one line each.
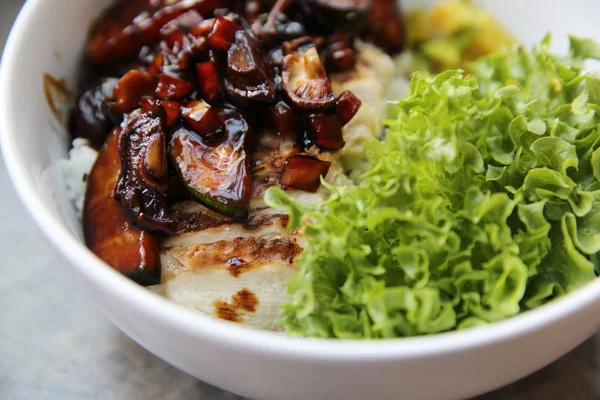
0 0 600 362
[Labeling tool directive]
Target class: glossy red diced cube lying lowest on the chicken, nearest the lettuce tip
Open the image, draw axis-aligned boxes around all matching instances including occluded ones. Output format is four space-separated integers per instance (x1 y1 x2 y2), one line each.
280 154 331 192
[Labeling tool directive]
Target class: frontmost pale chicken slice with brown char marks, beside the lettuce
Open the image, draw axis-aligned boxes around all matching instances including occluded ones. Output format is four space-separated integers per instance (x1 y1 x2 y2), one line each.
153 237 302 330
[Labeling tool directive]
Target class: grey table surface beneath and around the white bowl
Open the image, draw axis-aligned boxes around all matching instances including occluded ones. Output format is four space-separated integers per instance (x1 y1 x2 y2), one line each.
0 0 600 400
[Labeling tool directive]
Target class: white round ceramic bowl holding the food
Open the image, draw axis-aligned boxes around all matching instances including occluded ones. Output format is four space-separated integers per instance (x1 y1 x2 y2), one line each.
0 0 600 400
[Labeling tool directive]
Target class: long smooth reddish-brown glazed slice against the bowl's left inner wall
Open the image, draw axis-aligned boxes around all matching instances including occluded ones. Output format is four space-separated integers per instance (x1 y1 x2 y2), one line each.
83 129 161 285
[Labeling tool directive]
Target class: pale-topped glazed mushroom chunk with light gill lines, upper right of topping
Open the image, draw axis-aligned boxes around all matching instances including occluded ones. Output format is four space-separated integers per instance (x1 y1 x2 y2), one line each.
281 46 335 110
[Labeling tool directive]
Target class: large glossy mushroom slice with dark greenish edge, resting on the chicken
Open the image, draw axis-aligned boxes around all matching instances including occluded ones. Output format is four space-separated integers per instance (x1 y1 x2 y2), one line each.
169 109 253 218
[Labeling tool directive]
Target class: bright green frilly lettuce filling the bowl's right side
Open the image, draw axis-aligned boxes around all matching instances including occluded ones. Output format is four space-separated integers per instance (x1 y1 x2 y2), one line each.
266 37 600 338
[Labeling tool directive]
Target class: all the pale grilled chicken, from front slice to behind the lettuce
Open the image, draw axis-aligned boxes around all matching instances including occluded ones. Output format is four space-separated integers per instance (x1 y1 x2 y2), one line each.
150 44 394 330
